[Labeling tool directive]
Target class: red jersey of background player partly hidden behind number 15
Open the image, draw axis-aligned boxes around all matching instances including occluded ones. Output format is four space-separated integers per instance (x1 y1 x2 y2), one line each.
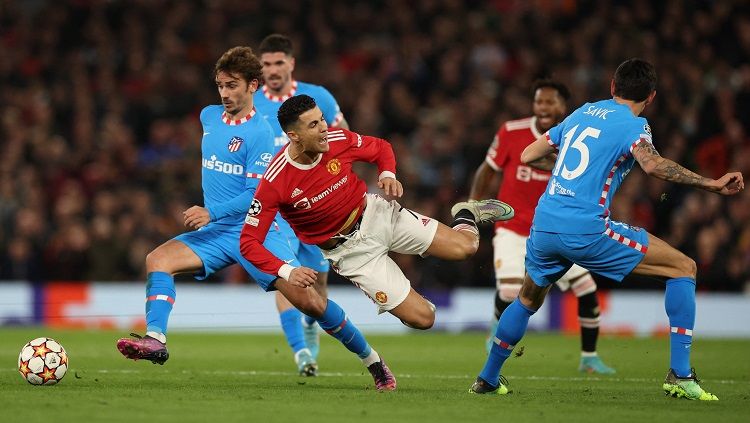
484 117 551 236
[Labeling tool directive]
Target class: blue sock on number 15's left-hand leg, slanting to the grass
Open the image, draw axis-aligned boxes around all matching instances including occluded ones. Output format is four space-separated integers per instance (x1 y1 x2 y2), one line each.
479 298 536 386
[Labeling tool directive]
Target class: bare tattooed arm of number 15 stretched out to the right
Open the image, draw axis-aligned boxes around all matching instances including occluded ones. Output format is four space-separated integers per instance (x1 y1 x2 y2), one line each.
632 139 745 195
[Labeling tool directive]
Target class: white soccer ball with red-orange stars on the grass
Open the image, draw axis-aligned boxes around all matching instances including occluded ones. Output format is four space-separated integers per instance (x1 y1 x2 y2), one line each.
18 337 68 385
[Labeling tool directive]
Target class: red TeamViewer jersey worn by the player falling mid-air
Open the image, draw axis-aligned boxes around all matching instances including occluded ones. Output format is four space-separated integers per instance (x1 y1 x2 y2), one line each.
240 129 396 275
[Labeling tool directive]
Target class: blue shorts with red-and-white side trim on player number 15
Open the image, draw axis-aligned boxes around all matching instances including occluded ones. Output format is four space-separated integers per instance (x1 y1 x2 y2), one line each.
526 221 648 287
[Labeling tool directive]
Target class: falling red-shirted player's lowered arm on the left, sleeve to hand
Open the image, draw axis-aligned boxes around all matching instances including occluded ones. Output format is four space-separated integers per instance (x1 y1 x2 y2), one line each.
240 185 316 288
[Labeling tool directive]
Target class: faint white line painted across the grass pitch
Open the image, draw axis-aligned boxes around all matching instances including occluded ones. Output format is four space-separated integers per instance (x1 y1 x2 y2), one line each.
0 368 750 385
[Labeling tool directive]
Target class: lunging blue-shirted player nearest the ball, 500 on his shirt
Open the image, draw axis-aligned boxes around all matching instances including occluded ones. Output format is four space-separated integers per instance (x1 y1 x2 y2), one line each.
117 47 396 390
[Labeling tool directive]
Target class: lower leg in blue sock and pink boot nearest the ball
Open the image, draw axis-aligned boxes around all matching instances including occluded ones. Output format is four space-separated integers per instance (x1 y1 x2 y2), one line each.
117 272 175 364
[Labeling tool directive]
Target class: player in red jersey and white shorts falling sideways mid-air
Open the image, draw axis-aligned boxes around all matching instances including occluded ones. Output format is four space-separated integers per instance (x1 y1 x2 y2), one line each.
240 95 513 348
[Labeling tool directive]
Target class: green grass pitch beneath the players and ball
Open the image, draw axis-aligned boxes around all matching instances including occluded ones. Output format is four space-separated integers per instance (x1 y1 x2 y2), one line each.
0 328 750 423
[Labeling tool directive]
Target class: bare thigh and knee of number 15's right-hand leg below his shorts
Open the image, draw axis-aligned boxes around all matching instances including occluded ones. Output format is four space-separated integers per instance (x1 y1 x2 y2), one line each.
633 234 696 278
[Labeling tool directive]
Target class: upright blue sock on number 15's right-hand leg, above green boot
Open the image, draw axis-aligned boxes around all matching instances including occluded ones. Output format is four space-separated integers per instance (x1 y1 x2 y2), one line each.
664 278 695 377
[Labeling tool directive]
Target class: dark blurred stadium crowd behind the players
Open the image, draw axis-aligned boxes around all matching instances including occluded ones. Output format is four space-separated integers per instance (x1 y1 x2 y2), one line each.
0 0 750 291
